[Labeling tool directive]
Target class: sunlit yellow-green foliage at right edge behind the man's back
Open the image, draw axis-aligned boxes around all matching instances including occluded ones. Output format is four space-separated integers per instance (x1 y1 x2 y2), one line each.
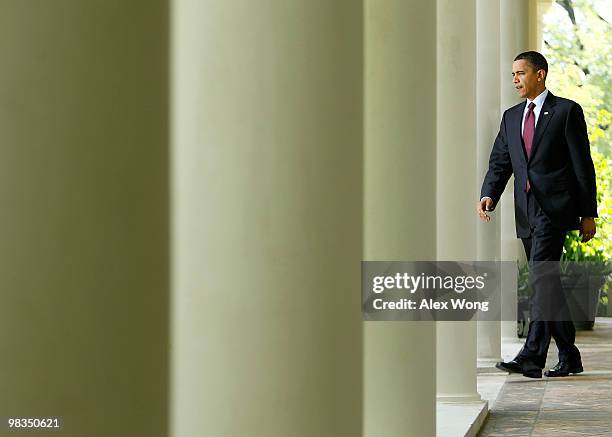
544 0 612 263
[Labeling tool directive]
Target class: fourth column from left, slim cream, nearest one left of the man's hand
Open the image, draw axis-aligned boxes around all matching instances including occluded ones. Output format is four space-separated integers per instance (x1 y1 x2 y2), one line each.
436 0 480 402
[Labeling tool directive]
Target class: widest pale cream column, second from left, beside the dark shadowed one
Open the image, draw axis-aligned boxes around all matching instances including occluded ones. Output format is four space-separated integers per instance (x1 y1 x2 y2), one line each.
170 0 363 437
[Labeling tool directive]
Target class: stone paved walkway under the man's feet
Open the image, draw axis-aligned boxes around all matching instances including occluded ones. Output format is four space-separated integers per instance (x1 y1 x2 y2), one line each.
478 318 612 437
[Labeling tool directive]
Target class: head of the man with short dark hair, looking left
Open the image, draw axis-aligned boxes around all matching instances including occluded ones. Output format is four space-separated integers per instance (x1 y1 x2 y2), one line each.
512 51 548 100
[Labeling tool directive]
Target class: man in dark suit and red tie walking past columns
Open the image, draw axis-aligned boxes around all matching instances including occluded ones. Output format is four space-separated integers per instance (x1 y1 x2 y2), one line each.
477 51 597 378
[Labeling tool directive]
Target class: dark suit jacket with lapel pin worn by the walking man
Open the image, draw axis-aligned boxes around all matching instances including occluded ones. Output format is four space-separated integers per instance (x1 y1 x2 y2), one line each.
481 90 597 238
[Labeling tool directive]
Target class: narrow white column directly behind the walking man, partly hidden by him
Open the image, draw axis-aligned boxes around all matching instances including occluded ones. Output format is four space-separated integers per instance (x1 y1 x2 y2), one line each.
500 0 529 341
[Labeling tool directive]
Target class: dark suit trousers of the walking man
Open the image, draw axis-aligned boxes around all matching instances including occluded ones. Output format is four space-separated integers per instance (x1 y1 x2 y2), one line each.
518 192 580 368
